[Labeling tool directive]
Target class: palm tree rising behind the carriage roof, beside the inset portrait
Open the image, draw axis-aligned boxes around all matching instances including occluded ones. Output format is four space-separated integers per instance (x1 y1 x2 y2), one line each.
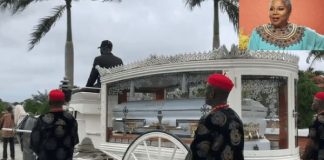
186 0 239 49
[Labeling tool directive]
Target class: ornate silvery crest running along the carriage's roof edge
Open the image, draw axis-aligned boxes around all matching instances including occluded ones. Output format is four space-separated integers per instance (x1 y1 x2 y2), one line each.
96 46 299 76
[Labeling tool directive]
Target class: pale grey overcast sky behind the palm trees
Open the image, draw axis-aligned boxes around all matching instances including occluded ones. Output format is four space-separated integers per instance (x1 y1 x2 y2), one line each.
0 0 324 102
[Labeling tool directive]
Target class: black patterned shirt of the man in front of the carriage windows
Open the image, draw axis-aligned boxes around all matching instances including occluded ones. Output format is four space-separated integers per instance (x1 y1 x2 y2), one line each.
190 108 244 160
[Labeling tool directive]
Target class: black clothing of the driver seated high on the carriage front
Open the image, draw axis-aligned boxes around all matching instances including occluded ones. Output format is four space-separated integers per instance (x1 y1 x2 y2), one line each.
86 53 123 87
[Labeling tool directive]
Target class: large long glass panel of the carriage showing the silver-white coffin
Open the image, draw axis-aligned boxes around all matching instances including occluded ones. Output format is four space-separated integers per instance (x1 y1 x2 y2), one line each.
107 71 219 143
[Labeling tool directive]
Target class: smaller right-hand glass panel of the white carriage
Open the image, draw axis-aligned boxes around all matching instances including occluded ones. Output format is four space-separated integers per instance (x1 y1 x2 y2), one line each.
242 75 288 150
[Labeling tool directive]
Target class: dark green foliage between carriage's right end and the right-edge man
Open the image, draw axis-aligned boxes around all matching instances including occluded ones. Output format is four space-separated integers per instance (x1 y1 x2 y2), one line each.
297 71 320 128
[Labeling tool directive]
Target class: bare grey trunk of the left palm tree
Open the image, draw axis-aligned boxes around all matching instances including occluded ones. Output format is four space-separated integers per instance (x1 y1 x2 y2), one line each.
65 0 74 87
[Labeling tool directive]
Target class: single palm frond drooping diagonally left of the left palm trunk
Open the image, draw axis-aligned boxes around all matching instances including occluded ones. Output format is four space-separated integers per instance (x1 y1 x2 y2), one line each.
28 5 66 50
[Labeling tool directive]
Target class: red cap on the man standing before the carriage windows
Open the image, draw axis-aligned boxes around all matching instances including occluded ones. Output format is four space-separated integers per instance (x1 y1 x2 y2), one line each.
208 74 234 92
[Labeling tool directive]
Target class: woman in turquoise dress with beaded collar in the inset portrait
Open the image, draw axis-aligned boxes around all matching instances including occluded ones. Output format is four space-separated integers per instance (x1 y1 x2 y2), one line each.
248 0 324 50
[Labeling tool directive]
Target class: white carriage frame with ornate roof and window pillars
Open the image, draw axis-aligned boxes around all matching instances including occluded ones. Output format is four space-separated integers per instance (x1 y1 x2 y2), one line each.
97 48 299 160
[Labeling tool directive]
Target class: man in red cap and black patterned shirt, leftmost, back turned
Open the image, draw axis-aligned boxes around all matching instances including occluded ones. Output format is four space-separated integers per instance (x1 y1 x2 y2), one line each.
30 90 79 160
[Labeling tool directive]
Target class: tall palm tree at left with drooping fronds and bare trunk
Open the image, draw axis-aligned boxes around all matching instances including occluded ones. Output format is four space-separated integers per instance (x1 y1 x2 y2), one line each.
0 0 120 87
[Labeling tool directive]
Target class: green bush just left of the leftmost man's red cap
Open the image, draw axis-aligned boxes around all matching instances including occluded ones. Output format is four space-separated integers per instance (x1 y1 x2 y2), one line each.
25 91 49 115
